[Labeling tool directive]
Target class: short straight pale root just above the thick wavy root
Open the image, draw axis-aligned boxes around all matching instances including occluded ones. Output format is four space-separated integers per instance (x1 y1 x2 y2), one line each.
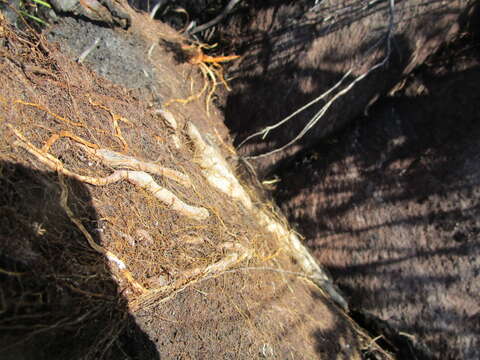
78 144 192 188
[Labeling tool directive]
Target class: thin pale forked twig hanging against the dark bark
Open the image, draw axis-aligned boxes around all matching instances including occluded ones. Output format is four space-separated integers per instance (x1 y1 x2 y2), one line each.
240 0 395 159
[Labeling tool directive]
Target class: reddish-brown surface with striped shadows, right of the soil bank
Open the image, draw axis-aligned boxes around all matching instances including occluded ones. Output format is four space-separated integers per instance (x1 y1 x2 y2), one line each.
276 26 480 359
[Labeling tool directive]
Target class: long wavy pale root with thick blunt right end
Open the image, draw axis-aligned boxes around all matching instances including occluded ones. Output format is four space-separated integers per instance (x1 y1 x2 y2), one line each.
8 124 210 221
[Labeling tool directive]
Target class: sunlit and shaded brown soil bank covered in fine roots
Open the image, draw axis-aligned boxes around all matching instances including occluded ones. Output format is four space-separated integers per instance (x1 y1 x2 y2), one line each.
0 6 391 359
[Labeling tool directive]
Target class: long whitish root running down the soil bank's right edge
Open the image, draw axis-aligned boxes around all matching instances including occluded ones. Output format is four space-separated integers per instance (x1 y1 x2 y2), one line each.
187 123 348 310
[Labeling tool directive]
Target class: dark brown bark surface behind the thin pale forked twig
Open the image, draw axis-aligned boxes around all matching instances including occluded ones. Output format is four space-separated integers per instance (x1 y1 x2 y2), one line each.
222 0 471 173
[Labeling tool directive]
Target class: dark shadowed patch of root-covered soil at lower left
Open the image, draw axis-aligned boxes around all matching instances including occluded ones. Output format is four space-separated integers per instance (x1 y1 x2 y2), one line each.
0 160 159 360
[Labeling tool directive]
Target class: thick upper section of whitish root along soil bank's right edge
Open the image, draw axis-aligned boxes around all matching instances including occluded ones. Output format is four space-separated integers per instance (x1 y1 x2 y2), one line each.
187 122 252 210
